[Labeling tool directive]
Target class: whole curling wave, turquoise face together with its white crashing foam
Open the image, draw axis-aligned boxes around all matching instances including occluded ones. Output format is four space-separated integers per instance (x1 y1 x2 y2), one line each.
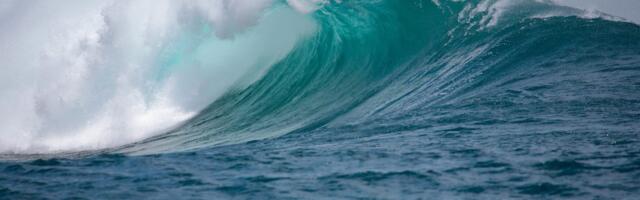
0 0 640 154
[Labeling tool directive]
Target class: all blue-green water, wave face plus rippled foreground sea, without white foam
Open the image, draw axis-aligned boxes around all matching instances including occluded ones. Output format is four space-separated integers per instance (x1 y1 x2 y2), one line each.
0 1 640 199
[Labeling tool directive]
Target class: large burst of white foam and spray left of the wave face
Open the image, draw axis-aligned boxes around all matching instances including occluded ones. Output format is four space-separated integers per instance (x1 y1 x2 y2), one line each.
0 0 315 153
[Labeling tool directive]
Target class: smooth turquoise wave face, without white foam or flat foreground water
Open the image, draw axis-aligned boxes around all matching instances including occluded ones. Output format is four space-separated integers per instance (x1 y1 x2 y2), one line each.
120 1 640 154
